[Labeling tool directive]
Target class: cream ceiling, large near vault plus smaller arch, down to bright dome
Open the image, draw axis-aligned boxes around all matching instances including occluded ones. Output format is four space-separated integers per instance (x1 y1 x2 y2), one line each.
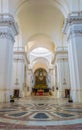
10 0 68 70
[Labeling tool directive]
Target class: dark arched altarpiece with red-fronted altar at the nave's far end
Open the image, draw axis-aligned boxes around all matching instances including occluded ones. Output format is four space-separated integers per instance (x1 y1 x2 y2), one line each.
32 68 49 96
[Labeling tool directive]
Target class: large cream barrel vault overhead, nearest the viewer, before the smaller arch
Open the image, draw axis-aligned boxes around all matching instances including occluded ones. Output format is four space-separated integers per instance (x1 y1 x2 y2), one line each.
10 0 64 45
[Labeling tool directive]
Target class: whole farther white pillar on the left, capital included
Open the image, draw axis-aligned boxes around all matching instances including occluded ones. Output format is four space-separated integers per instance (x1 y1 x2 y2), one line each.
12 47 25 97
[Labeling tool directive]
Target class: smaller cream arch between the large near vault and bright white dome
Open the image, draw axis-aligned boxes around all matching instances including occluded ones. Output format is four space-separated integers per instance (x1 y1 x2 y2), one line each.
27 34 55 53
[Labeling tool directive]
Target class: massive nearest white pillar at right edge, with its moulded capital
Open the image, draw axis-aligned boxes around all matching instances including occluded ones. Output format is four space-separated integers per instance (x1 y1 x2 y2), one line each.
63 13 82 102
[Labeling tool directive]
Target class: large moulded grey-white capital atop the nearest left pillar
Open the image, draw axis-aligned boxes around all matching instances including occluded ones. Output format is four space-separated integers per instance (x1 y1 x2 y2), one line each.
0 14 18 41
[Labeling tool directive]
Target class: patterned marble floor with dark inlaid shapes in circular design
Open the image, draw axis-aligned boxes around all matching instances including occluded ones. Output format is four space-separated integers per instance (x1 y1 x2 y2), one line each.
0 96 82 130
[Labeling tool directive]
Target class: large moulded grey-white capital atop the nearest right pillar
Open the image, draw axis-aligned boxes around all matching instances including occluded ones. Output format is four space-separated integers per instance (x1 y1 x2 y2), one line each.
63 15 82 40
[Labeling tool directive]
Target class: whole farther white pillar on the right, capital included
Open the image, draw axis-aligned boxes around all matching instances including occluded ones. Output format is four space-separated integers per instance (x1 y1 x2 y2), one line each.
55 47 71 97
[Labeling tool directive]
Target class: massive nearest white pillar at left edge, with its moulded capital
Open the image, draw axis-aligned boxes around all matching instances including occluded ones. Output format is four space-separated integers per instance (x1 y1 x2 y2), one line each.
0 14 18 102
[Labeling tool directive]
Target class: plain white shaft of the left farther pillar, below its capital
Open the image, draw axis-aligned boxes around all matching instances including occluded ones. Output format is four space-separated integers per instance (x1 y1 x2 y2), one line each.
12 58 25 97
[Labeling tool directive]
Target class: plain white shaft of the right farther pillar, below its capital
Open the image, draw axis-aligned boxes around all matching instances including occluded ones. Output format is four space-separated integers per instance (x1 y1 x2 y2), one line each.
57 59 71 93
